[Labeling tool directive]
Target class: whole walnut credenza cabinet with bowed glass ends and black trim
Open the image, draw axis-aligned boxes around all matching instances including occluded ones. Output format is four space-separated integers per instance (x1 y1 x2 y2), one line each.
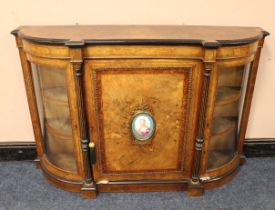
12 25 268 198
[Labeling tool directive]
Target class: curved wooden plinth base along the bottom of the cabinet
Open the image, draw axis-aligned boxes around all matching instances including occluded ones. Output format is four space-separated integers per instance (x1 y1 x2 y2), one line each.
36 160 241 199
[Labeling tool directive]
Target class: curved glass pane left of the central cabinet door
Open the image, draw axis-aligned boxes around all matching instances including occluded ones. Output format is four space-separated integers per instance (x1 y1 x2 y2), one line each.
31 64 76 172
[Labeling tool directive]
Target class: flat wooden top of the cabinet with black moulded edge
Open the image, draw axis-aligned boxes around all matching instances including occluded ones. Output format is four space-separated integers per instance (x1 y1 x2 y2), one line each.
12 25 268 48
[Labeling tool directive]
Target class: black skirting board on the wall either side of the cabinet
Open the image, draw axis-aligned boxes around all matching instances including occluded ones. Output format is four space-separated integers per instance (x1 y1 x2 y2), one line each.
0 138 275 161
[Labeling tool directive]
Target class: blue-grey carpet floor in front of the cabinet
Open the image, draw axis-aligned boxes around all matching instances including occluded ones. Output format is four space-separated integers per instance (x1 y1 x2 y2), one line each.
0 158 275 210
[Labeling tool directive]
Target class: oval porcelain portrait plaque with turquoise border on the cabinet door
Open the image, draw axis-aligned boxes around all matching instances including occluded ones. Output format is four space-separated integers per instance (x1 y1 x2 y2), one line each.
131 112 155 141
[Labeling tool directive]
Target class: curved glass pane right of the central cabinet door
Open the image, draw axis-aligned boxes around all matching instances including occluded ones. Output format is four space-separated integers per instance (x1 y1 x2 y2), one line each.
208 64 250 169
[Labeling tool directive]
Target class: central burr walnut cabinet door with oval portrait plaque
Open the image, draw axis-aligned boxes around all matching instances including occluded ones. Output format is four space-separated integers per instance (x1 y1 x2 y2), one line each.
84 59 202 181
